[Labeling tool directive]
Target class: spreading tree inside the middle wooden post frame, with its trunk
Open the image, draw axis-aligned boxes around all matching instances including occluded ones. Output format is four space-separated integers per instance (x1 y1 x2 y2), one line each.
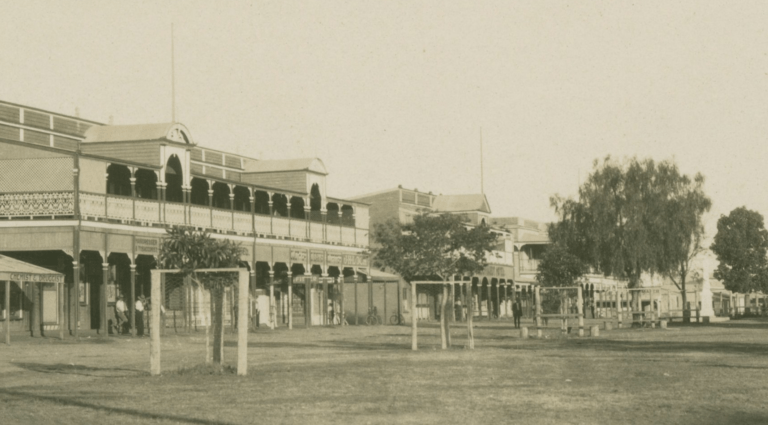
373 213 497 347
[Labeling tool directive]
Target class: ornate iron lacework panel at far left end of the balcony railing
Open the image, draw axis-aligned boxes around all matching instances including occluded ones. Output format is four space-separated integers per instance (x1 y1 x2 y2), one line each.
0 192 75 216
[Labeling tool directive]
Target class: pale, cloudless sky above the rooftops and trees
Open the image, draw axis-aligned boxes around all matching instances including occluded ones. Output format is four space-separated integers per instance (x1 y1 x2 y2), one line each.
0 0 768 237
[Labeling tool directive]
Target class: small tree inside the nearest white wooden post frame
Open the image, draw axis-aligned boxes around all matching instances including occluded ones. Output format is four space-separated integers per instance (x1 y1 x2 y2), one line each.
159 227 245 365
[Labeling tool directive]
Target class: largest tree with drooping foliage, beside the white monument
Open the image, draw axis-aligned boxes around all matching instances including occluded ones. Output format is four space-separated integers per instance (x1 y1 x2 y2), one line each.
550 157 711 316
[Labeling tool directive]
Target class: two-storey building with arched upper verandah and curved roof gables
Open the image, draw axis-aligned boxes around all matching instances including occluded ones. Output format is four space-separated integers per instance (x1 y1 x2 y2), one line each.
0 102 369 334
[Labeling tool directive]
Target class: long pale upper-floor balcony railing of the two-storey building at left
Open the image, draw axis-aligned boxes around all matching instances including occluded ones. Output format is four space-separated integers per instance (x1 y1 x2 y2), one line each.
0 192 368 246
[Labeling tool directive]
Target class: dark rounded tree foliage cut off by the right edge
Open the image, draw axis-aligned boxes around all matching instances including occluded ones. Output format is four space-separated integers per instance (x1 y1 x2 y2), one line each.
711 207 768 293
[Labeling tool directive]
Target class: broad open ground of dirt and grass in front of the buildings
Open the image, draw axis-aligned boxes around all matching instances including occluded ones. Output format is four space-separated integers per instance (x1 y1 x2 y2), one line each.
0 320 768 425
